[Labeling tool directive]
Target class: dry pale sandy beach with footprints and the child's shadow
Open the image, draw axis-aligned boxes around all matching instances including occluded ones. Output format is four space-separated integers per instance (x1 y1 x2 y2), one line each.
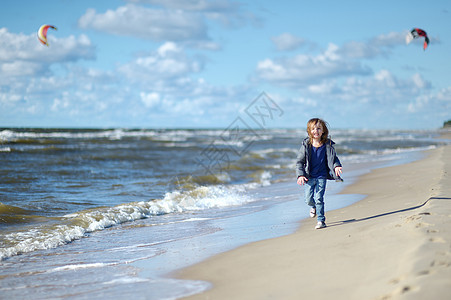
176 132 451 300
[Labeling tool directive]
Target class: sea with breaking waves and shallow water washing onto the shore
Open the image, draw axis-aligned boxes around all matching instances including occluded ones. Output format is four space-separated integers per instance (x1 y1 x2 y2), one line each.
0 128 449 299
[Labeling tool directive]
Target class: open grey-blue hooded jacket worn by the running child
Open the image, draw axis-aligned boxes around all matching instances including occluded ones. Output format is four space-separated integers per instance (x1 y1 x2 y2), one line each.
296 137 343 181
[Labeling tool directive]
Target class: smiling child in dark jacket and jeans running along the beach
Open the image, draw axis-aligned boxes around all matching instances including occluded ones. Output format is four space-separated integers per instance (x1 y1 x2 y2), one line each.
296 118 342 229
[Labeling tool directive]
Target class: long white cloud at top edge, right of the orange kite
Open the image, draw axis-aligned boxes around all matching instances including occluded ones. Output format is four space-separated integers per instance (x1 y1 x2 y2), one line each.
78 0 261 45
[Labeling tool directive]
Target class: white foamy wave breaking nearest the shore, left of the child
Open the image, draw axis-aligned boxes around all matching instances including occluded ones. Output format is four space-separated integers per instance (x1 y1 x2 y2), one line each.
0 185 254 260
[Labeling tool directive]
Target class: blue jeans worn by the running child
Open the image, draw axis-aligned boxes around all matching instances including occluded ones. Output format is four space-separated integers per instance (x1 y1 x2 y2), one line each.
304 178 327 222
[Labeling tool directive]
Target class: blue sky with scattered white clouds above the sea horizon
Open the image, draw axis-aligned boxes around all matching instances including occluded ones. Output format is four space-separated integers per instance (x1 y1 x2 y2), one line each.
0 0 451 129
